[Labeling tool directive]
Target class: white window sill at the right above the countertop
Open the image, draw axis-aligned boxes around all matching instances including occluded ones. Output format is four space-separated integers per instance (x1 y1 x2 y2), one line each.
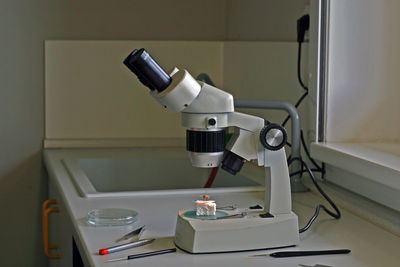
311 143 400 211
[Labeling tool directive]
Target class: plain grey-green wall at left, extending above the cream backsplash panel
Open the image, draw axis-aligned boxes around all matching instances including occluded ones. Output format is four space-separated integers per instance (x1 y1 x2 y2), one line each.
0 0 225 266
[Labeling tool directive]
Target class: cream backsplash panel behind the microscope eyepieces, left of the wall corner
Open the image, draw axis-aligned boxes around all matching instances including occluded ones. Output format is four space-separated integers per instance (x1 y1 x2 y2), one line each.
45 41 223 142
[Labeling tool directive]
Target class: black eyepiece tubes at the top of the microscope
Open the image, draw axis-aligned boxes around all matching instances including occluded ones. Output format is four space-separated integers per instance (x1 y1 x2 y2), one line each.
124 48 171 92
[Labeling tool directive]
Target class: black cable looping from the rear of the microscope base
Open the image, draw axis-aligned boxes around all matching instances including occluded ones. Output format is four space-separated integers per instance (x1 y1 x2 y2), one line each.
288 157 341 233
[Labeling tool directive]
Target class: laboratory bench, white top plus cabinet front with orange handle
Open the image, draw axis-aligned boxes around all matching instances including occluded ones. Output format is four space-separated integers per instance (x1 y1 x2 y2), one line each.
44 149 400 267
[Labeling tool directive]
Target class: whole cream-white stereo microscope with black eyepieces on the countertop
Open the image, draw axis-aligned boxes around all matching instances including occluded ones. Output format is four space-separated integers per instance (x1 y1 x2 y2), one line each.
124 48 299 253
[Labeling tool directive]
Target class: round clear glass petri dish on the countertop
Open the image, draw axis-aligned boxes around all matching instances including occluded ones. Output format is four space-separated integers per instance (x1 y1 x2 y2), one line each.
87 208 138 226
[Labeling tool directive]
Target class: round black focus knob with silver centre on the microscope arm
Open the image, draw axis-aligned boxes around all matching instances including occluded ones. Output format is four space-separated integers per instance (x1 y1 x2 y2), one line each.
260 123 287 151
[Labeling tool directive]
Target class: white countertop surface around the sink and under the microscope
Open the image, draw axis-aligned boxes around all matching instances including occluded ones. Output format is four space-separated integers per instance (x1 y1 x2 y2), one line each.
44 149 400 267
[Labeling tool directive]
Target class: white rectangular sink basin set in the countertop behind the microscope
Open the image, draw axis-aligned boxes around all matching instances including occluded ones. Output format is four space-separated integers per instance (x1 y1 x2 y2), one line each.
62 149 264 197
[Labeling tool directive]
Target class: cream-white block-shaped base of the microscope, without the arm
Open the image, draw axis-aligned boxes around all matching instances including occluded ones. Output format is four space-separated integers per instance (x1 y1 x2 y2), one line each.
175 211 299 253
